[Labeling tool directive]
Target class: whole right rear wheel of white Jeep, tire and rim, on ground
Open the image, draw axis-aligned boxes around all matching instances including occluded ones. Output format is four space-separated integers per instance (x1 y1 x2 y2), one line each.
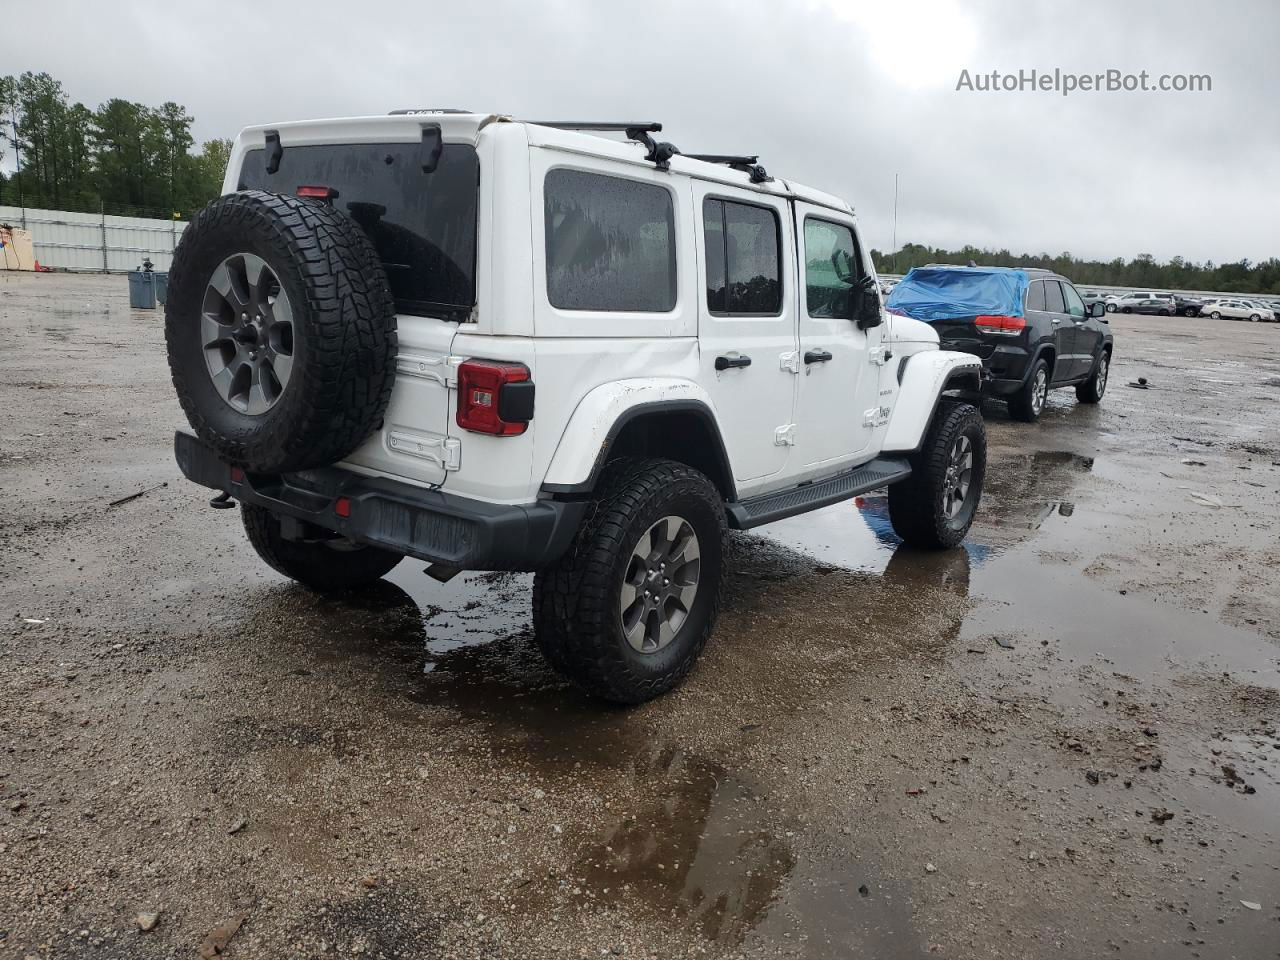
534 460 726 703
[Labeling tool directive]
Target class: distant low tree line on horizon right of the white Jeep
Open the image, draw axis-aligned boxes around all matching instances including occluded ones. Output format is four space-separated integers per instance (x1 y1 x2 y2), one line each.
872 243 1280 293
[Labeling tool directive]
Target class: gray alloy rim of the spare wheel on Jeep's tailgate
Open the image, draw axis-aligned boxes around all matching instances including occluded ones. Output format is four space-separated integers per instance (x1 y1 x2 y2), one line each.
200 253 293 416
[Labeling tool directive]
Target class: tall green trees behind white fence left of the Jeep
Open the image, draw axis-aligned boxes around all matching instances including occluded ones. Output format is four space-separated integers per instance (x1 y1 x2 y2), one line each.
0 72 232 219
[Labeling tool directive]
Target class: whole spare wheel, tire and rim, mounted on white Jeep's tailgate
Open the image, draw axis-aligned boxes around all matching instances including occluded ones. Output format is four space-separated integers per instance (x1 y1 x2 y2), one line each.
165 191 397 472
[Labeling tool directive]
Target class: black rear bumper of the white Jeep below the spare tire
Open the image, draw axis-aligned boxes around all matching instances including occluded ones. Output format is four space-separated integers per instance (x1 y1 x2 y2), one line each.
173 430 588 571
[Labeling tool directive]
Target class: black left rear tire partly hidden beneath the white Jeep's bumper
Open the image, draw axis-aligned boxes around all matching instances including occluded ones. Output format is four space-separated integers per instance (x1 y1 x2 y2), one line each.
241 503 403 593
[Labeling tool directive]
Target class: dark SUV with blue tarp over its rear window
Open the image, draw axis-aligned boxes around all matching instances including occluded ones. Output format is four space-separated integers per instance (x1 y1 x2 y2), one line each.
884 265 1114 422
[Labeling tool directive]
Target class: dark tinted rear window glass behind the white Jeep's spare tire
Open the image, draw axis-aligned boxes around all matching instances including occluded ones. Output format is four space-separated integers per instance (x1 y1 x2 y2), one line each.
239 143 480 320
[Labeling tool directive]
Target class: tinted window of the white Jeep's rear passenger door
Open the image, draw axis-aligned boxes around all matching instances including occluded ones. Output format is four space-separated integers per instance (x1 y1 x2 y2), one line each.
703 197 782 316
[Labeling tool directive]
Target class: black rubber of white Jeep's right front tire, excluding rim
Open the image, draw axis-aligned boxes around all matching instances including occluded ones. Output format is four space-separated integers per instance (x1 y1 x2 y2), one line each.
888 401 987 549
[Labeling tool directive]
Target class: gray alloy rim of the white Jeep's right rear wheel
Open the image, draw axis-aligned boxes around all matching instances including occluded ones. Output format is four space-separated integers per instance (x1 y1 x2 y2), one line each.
618 516 701 653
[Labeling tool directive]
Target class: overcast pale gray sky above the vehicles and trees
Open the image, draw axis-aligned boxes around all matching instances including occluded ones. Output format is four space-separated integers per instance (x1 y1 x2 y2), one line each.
0 0 1280 262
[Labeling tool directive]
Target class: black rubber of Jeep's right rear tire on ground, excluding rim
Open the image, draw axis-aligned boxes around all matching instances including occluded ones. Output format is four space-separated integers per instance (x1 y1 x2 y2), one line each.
534 460 726 704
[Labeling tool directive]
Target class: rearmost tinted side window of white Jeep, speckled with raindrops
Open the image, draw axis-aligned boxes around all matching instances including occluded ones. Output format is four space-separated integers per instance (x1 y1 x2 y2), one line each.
543 170 676 314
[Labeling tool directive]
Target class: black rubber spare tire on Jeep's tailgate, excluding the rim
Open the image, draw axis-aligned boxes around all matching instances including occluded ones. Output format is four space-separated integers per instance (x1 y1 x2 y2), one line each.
165 191 397 472
